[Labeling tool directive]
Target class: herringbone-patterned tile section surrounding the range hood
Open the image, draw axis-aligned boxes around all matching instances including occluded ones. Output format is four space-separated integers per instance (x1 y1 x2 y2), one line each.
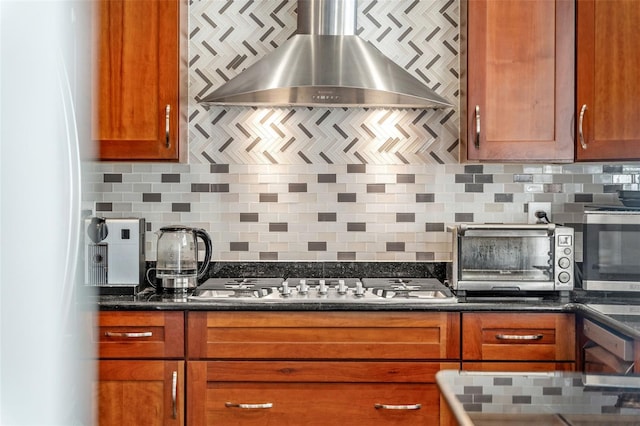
188 0 460 164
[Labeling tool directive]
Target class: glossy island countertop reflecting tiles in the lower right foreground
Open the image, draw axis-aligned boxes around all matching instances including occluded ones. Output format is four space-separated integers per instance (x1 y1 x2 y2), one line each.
436 370 640 426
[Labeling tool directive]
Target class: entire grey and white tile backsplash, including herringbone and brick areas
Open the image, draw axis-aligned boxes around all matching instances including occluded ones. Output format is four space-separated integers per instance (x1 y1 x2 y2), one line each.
84 0 640 262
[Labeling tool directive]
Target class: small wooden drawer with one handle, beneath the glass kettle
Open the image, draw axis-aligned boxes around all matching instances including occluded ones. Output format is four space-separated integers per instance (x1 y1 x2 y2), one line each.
92 312 184 358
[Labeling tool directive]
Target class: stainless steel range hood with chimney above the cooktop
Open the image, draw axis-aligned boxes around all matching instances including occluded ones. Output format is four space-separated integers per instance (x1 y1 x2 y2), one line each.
199 0 452 108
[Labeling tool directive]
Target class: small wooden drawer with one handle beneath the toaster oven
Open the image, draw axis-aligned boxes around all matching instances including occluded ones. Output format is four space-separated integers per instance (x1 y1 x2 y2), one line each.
462 312 576 361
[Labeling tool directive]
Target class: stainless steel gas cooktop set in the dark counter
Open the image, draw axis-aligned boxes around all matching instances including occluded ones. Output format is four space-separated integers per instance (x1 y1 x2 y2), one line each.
189 278 457 304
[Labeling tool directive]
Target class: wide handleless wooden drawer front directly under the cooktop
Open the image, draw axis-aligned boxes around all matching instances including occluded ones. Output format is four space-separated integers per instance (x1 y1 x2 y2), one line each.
187 312 460 360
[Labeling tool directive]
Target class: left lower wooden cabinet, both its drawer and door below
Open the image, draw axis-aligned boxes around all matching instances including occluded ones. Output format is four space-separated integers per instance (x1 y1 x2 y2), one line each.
94 311 185 426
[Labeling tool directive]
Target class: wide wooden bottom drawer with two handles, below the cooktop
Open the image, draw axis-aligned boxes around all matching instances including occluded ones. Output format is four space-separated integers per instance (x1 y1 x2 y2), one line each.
187 361 458 426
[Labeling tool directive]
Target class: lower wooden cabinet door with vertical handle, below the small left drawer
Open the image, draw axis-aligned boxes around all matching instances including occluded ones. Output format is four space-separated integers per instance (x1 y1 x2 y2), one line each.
94 360 184 426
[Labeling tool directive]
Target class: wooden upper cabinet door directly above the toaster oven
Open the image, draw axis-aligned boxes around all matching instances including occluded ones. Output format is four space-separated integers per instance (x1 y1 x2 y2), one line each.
460 0 575 162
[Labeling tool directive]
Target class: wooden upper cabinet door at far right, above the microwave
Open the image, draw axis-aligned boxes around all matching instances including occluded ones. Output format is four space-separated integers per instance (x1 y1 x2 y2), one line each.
576 0 640 161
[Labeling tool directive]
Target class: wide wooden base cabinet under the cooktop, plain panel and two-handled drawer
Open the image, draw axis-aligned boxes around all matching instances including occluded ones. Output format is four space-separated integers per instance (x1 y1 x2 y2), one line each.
187 312 460 426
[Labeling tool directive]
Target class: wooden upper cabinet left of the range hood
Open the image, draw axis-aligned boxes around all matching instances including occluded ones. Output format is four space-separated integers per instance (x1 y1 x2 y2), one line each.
92 0 180 161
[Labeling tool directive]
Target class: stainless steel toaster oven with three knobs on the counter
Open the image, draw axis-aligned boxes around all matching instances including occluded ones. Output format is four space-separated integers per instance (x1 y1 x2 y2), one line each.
447 224 574 294
